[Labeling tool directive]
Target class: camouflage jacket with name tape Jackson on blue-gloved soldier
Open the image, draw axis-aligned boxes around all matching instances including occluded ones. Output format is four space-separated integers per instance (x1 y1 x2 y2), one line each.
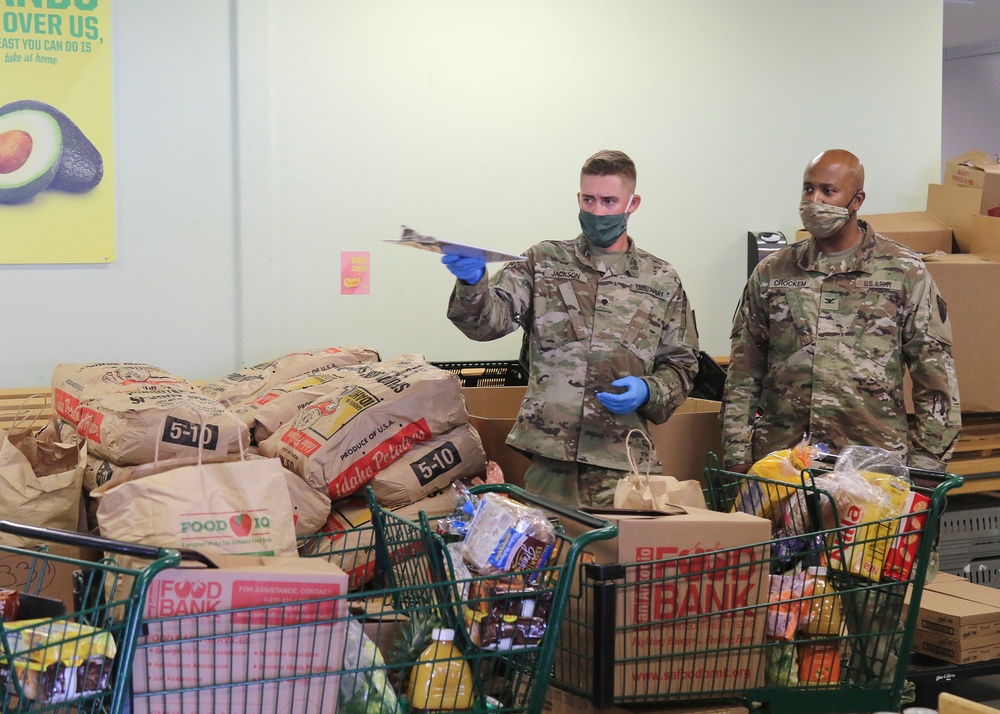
448 234 698 473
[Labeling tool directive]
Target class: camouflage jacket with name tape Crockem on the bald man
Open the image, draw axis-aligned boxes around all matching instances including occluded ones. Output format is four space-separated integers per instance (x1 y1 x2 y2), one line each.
722 221 961 470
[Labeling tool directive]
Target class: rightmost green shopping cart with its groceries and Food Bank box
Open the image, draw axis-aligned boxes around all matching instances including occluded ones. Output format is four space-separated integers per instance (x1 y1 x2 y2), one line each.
552 443 962 714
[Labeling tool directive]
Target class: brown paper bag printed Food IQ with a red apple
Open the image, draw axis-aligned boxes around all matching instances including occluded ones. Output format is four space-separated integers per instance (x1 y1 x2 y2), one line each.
97 459 296 555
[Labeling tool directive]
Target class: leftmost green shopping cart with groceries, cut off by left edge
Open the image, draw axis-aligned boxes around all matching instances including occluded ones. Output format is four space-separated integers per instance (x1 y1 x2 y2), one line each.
0 521 180 714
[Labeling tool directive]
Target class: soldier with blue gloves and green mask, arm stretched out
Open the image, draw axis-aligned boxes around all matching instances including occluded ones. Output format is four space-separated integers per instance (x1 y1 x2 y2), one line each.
442 151 698 506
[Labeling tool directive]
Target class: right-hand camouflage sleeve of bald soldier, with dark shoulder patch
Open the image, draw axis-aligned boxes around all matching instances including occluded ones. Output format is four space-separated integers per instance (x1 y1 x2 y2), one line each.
903 269 962 471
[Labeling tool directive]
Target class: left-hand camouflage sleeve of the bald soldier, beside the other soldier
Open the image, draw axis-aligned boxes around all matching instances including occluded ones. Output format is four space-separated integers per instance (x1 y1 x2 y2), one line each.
720 271 768 466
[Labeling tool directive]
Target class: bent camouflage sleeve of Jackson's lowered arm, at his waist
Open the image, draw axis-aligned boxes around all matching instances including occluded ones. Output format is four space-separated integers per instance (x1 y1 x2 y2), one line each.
639 286 698 424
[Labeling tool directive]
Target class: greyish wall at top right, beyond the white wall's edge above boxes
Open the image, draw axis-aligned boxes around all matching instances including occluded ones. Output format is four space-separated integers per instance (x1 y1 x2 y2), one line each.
941 42 1000 175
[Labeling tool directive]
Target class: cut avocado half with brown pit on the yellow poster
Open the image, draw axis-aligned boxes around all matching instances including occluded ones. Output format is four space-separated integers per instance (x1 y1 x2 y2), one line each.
0 109 63 203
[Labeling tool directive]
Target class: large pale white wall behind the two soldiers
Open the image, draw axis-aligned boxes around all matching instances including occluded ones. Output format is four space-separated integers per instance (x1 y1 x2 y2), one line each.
0 0 942 386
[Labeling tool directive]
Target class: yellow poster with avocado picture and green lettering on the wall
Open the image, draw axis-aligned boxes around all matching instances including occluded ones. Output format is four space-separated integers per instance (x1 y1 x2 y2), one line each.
0 0 115 264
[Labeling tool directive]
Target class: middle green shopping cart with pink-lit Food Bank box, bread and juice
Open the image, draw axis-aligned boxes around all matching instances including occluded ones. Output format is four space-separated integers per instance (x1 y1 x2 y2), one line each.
126 484 615 714
